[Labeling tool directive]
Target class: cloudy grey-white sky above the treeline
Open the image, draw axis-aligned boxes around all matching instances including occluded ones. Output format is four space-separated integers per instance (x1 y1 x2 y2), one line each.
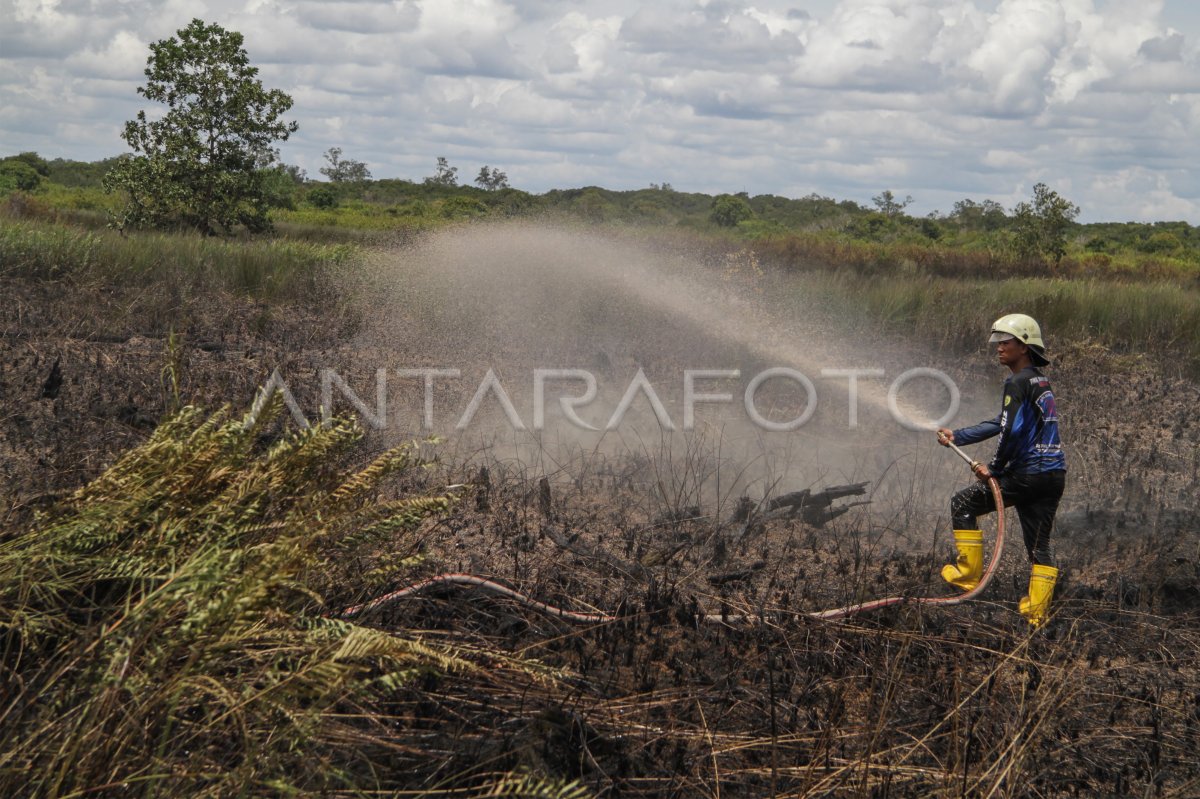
0 0 1200 224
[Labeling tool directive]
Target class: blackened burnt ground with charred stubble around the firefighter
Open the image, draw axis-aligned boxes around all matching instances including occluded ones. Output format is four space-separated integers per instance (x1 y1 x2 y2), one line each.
0 226 1200 797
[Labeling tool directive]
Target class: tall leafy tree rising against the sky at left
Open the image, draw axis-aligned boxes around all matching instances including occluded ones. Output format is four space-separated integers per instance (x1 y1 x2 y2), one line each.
104 19 296 235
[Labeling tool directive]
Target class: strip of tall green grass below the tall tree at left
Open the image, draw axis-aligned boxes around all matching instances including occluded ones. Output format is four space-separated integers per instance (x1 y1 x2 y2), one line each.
0 216 360 298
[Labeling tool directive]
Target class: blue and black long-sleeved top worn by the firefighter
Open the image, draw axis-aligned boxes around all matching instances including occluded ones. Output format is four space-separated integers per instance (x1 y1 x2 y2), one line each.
954 366 1067 476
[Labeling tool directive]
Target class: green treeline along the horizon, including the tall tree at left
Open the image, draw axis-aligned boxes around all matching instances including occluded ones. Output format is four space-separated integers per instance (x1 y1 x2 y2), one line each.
7 14 1200 280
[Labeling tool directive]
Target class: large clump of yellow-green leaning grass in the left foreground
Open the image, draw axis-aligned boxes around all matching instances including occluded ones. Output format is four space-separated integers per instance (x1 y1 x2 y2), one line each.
0 402 576 797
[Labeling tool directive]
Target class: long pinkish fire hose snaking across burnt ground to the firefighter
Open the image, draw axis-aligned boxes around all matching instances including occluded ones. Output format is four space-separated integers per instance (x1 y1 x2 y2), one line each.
338 437 1004 624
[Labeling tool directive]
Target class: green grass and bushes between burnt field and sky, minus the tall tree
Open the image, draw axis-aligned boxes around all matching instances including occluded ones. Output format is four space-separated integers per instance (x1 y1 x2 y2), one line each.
0 148 1200 372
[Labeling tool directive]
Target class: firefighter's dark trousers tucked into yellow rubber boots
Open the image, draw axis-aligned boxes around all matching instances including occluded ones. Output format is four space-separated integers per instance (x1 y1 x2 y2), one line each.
950 470 1067 566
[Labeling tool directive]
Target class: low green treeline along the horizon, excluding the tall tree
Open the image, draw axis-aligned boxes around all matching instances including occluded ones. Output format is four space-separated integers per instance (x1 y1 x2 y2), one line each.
0 148 1200 276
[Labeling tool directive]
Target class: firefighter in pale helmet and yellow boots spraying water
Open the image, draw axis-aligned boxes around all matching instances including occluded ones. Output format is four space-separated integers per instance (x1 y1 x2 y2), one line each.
937 313 1067 627
